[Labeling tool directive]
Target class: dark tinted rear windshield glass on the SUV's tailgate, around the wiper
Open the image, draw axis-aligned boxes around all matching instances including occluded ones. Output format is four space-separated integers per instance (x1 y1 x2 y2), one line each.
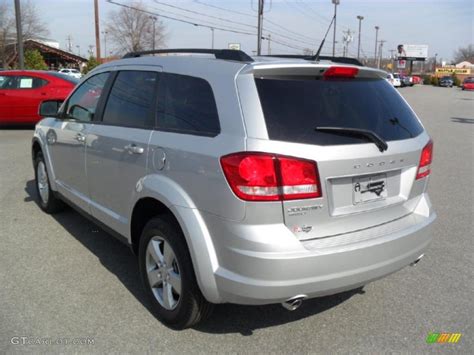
255 76 423 145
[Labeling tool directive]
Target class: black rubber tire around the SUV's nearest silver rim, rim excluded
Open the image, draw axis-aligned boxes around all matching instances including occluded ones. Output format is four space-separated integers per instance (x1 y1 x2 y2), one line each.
138 215 213 330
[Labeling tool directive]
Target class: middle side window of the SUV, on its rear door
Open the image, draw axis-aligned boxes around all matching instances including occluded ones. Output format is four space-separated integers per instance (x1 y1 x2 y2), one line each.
102 70 158 128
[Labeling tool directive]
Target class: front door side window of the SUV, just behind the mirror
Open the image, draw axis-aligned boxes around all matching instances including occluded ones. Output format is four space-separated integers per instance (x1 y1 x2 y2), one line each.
65 73 109 122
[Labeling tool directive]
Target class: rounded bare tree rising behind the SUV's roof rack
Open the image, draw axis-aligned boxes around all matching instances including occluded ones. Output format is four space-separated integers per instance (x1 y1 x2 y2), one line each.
106 1 166 53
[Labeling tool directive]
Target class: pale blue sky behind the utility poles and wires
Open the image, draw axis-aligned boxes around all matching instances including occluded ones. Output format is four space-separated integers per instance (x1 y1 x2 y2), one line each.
33 0 474 60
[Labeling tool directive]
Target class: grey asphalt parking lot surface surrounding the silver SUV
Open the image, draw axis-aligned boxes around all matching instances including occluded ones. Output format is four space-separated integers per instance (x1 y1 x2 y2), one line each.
0 86 474 353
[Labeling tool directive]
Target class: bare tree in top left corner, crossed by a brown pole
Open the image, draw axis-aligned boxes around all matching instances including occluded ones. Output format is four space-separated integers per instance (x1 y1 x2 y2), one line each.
0 0 49 66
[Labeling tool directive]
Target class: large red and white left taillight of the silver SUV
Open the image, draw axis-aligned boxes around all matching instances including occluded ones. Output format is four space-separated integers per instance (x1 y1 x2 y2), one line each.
221 152 321 201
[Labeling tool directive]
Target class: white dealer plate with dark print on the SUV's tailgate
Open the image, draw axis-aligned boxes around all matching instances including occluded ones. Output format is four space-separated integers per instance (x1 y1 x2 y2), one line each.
352 174 387 205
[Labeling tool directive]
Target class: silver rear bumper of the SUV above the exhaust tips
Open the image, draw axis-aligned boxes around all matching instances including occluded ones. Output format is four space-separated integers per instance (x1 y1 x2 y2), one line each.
206 196 436 305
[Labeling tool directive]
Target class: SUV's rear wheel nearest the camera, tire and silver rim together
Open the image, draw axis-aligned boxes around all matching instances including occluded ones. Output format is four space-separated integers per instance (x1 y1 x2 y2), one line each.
138 216 212 329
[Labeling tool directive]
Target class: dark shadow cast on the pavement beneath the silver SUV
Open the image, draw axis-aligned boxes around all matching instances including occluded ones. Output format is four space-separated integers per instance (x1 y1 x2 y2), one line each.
24 180 365 336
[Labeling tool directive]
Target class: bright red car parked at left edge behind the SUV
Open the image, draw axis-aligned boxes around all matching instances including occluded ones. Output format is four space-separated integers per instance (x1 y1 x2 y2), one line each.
0 70 79 125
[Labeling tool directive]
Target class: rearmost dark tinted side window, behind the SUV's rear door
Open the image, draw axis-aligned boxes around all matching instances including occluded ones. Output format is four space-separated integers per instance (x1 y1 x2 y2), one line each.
158 73 220 136
